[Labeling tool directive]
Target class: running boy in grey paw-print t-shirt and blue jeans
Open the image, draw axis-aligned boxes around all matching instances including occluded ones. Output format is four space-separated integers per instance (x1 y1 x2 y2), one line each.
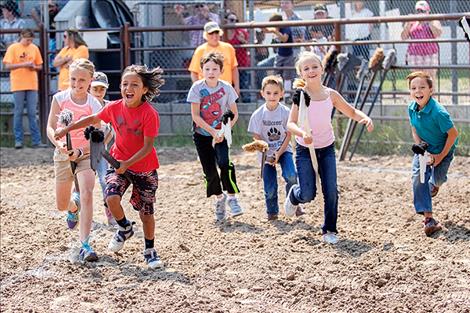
248 75 301 221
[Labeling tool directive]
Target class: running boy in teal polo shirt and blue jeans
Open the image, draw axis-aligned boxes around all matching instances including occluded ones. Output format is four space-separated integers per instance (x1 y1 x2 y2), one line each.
406 72 458 236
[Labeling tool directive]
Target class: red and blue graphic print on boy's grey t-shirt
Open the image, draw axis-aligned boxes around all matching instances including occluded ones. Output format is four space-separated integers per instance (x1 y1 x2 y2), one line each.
200 87 225 129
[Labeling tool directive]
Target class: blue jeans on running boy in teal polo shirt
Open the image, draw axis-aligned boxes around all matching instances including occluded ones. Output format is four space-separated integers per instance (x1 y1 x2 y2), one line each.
411 152 454 214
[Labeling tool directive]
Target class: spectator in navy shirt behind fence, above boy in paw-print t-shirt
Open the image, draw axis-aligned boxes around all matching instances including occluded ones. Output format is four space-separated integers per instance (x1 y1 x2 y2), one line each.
264 14 295 97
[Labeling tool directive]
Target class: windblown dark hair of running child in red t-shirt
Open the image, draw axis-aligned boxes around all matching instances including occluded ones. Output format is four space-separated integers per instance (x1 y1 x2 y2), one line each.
122 64 165 102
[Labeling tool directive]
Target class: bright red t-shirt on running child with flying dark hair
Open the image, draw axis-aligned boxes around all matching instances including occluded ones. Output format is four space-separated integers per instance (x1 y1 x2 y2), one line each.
98 99 160 173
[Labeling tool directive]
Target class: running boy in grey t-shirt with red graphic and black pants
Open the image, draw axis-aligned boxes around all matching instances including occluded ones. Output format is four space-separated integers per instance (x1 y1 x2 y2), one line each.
187 52 243 222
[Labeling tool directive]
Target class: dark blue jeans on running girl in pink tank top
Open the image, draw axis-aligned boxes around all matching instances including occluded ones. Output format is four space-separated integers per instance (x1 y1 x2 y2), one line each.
290 143 338 234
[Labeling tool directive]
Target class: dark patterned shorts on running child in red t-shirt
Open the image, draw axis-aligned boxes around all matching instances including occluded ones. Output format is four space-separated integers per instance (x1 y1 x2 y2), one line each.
105 168 158 215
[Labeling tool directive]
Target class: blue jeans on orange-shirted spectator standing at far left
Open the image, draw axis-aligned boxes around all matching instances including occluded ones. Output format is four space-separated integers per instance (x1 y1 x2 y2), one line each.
13 90 41 145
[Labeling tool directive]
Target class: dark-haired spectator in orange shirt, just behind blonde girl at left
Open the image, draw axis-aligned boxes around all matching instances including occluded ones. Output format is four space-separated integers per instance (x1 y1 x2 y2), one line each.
52 29 89 91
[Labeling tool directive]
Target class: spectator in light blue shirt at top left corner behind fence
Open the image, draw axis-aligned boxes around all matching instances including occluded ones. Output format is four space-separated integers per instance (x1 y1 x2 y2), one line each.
0 0 25 49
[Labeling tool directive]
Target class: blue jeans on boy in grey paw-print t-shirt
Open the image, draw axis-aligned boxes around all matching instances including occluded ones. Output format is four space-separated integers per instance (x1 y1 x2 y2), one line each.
263 151 297 214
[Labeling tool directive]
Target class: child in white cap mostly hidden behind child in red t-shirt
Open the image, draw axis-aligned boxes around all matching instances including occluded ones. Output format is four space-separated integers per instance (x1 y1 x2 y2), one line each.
90 72 116 226
